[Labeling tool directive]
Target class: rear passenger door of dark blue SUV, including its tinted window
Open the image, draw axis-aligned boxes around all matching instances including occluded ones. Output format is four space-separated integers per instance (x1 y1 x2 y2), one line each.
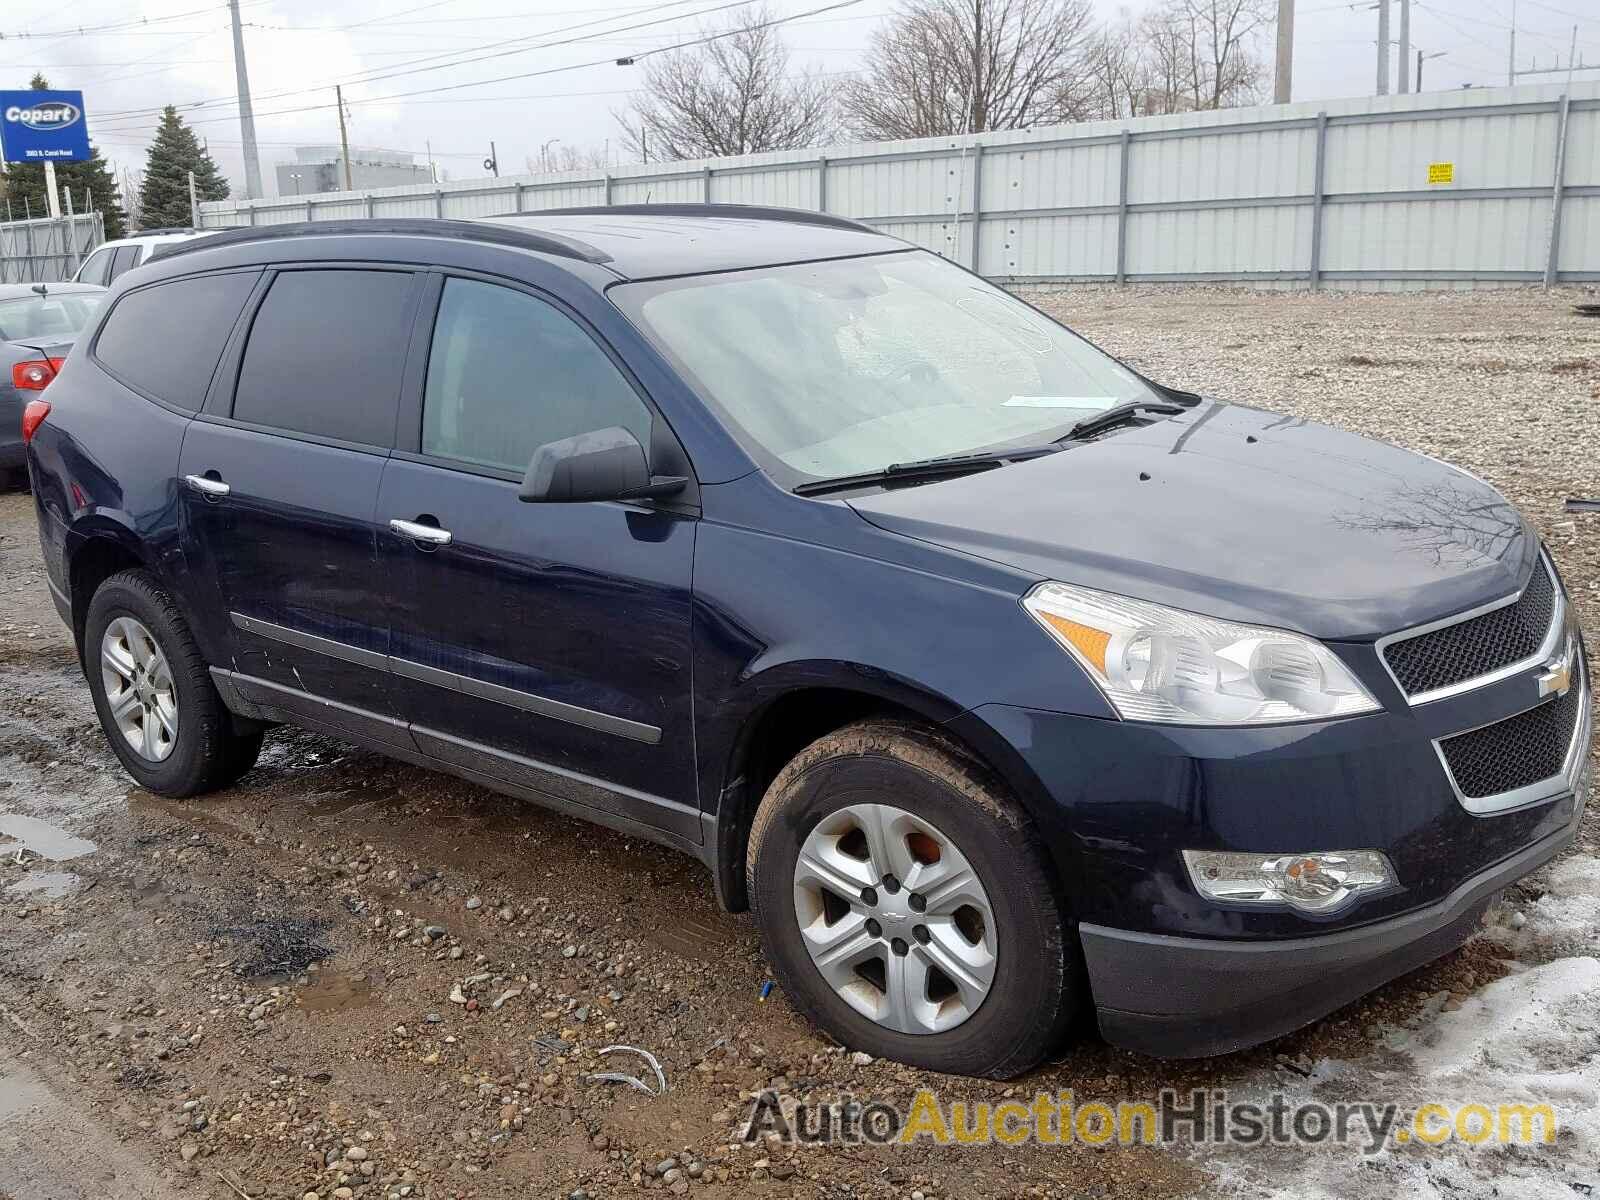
179 266 419 746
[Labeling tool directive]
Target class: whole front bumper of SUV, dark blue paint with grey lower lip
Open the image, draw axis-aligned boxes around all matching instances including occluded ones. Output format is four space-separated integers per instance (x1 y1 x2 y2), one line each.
966 614 1594 1058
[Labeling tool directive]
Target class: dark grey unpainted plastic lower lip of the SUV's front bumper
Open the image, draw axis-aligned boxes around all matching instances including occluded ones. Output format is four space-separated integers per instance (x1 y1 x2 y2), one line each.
1078 810 1582 1058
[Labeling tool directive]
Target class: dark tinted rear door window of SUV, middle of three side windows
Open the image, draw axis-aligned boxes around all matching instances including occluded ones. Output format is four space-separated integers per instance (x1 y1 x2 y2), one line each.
234 270 413 446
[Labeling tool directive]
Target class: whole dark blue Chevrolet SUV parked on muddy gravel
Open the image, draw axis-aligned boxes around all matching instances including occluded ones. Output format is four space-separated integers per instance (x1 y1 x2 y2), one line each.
27 206 1592 1077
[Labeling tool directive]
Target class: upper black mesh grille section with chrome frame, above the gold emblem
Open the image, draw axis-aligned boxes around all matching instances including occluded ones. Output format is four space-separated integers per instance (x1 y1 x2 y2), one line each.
1382 557 1558 696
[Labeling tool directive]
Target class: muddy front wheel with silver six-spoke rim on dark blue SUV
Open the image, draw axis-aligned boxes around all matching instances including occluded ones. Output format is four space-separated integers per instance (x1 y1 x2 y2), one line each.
747 720 1077 1078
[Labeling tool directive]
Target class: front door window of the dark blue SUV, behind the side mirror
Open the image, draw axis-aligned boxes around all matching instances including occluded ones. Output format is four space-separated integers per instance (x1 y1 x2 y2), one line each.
422 278 651 472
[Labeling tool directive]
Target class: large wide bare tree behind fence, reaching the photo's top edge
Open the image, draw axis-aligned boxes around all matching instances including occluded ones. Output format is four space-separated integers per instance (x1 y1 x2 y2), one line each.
843 0 1093 138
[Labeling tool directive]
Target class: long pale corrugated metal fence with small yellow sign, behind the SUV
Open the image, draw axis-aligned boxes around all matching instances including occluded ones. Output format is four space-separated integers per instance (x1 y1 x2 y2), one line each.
200 83 1600 286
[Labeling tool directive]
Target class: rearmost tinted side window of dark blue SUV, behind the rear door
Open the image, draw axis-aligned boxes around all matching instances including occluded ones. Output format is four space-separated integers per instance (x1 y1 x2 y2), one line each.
94 270 258 413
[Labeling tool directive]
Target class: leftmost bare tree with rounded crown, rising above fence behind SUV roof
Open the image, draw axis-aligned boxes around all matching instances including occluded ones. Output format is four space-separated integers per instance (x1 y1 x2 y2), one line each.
616 10 837 162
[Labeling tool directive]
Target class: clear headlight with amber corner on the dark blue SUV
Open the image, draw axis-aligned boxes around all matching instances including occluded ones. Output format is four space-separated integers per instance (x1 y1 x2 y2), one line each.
1022 582 1378 725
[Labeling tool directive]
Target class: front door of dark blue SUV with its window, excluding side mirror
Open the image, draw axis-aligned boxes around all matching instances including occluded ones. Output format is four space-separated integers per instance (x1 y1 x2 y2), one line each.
378 277 701 842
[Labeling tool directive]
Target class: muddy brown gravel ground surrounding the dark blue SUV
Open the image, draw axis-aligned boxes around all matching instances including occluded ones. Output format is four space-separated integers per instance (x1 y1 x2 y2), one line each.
0 290 1600 1200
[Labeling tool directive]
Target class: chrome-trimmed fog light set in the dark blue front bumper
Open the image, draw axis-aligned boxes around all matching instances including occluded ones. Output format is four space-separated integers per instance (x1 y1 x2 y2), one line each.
1184 850 1395 912
